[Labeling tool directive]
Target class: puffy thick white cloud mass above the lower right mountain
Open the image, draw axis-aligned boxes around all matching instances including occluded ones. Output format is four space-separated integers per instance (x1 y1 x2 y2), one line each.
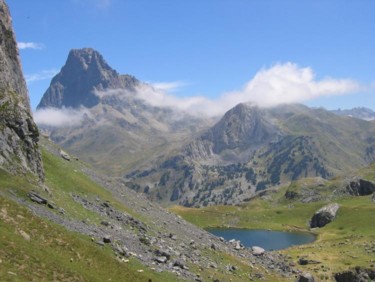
221 63 361 107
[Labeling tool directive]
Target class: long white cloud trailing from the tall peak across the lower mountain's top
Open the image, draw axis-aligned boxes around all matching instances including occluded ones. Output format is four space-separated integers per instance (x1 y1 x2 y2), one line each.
137 62 361 116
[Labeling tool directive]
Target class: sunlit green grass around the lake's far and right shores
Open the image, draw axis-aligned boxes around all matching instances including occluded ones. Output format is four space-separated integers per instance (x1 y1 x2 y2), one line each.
171 176 375 280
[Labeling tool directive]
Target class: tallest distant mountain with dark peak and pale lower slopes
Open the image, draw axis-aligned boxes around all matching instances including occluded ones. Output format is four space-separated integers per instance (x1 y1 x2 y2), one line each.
38 48 216 176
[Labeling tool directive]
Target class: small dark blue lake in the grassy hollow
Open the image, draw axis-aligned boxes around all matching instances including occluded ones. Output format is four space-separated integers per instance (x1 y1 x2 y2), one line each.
207 228 316 251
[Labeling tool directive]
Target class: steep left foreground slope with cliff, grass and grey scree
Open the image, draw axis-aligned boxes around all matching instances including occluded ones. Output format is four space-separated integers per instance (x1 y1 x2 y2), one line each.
0 6 292 281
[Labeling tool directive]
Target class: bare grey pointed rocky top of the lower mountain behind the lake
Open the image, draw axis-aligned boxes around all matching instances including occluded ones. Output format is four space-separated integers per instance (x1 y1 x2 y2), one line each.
186 103 280 163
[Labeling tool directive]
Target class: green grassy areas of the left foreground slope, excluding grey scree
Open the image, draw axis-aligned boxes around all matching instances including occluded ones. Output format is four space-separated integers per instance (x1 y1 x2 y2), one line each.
0 151 176 281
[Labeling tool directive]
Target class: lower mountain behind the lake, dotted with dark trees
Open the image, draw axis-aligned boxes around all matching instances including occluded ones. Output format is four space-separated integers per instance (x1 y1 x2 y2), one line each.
128 104 375 206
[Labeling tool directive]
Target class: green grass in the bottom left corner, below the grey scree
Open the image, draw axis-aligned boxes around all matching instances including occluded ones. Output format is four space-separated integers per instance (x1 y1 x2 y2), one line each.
0 195 180 281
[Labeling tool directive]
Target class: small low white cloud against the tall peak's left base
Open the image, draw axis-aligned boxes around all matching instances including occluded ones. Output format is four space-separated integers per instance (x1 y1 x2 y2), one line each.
34 108 90 127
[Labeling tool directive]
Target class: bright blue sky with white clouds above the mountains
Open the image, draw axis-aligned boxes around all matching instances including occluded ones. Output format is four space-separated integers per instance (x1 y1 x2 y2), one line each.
7 0 375 114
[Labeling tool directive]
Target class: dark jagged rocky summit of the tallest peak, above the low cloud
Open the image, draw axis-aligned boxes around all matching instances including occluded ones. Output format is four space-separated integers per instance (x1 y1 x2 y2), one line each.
37 48 138 109
